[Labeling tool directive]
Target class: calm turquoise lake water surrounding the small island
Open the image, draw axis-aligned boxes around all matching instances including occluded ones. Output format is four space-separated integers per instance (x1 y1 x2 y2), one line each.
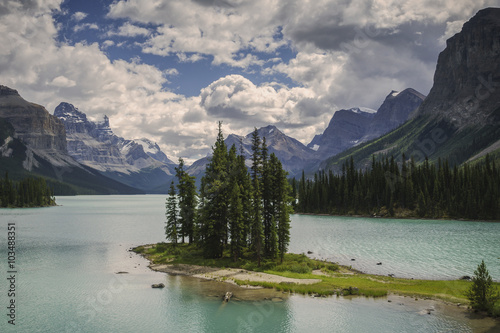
0 195 500 332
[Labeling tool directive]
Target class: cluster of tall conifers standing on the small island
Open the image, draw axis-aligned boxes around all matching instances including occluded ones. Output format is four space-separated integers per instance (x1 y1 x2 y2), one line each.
165 124 292 264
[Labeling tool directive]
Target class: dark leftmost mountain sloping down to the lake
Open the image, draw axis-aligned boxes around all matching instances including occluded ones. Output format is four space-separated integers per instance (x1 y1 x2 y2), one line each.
0 86 142 194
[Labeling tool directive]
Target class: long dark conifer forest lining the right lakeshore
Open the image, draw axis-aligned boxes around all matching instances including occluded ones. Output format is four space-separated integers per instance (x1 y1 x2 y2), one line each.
292 155 500 220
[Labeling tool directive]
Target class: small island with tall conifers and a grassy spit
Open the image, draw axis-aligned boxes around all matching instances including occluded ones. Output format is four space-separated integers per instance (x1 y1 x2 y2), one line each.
136 123 500 315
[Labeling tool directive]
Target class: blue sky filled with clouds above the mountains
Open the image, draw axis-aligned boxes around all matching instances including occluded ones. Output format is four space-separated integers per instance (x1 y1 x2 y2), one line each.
0 0 500 162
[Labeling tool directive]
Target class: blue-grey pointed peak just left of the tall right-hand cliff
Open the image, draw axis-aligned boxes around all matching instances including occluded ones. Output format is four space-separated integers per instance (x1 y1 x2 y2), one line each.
361 88 425 142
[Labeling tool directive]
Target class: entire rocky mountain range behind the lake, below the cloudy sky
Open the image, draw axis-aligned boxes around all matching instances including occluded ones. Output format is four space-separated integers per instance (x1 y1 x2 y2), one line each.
0 8 500 193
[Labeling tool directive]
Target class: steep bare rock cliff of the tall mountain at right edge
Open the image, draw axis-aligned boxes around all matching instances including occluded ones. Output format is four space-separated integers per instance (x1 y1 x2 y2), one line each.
415 8 500 129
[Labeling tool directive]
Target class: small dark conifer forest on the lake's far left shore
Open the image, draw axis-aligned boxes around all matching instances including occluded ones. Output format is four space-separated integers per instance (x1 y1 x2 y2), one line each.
0 172 56 208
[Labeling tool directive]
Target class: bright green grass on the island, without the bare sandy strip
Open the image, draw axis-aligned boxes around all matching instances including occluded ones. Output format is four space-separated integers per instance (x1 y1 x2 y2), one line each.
133 243 500 312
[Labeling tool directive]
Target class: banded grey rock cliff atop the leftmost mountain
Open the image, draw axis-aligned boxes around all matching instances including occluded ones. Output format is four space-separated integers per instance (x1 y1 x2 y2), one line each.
0 86 67 153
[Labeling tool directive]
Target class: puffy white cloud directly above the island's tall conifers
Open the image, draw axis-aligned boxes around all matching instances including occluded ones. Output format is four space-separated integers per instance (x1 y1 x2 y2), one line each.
200 75 331 142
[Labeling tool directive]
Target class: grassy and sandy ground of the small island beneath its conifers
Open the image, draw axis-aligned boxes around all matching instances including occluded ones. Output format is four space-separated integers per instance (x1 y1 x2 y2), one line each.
131 243 500 317
